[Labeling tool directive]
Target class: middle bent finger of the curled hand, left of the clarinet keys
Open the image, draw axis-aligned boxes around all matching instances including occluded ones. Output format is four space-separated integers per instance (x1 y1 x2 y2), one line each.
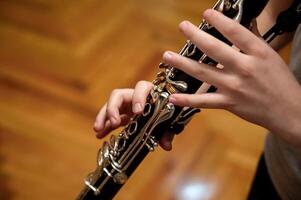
106 89 134 128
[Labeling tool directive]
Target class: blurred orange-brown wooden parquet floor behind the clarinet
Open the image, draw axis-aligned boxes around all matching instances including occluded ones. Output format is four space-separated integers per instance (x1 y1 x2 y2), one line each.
0 0 289 200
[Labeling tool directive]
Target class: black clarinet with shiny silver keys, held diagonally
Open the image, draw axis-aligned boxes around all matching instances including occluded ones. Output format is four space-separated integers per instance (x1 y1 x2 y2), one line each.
77 0 268 200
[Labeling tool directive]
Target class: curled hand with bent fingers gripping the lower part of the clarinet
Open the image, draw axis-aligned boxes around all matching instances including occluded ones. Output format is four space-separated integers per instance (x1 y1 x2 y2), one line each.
94 81 174 151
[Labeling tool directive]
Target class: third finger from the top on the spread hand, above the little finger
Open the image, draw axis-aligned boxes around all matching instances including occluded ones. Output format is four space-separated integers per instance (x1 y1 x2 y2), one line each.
163 51 227 87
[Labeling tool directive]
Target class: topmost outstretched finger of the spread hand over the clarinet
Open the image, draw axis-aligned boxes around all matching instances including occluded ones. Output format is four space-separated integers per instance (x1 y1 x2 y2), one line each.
204 9 265 55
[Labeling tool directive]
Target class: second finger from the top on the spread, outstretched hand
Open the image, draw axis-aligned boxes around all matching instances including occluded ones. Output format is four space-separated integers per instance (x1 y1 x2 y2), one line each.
180 21 242 67
